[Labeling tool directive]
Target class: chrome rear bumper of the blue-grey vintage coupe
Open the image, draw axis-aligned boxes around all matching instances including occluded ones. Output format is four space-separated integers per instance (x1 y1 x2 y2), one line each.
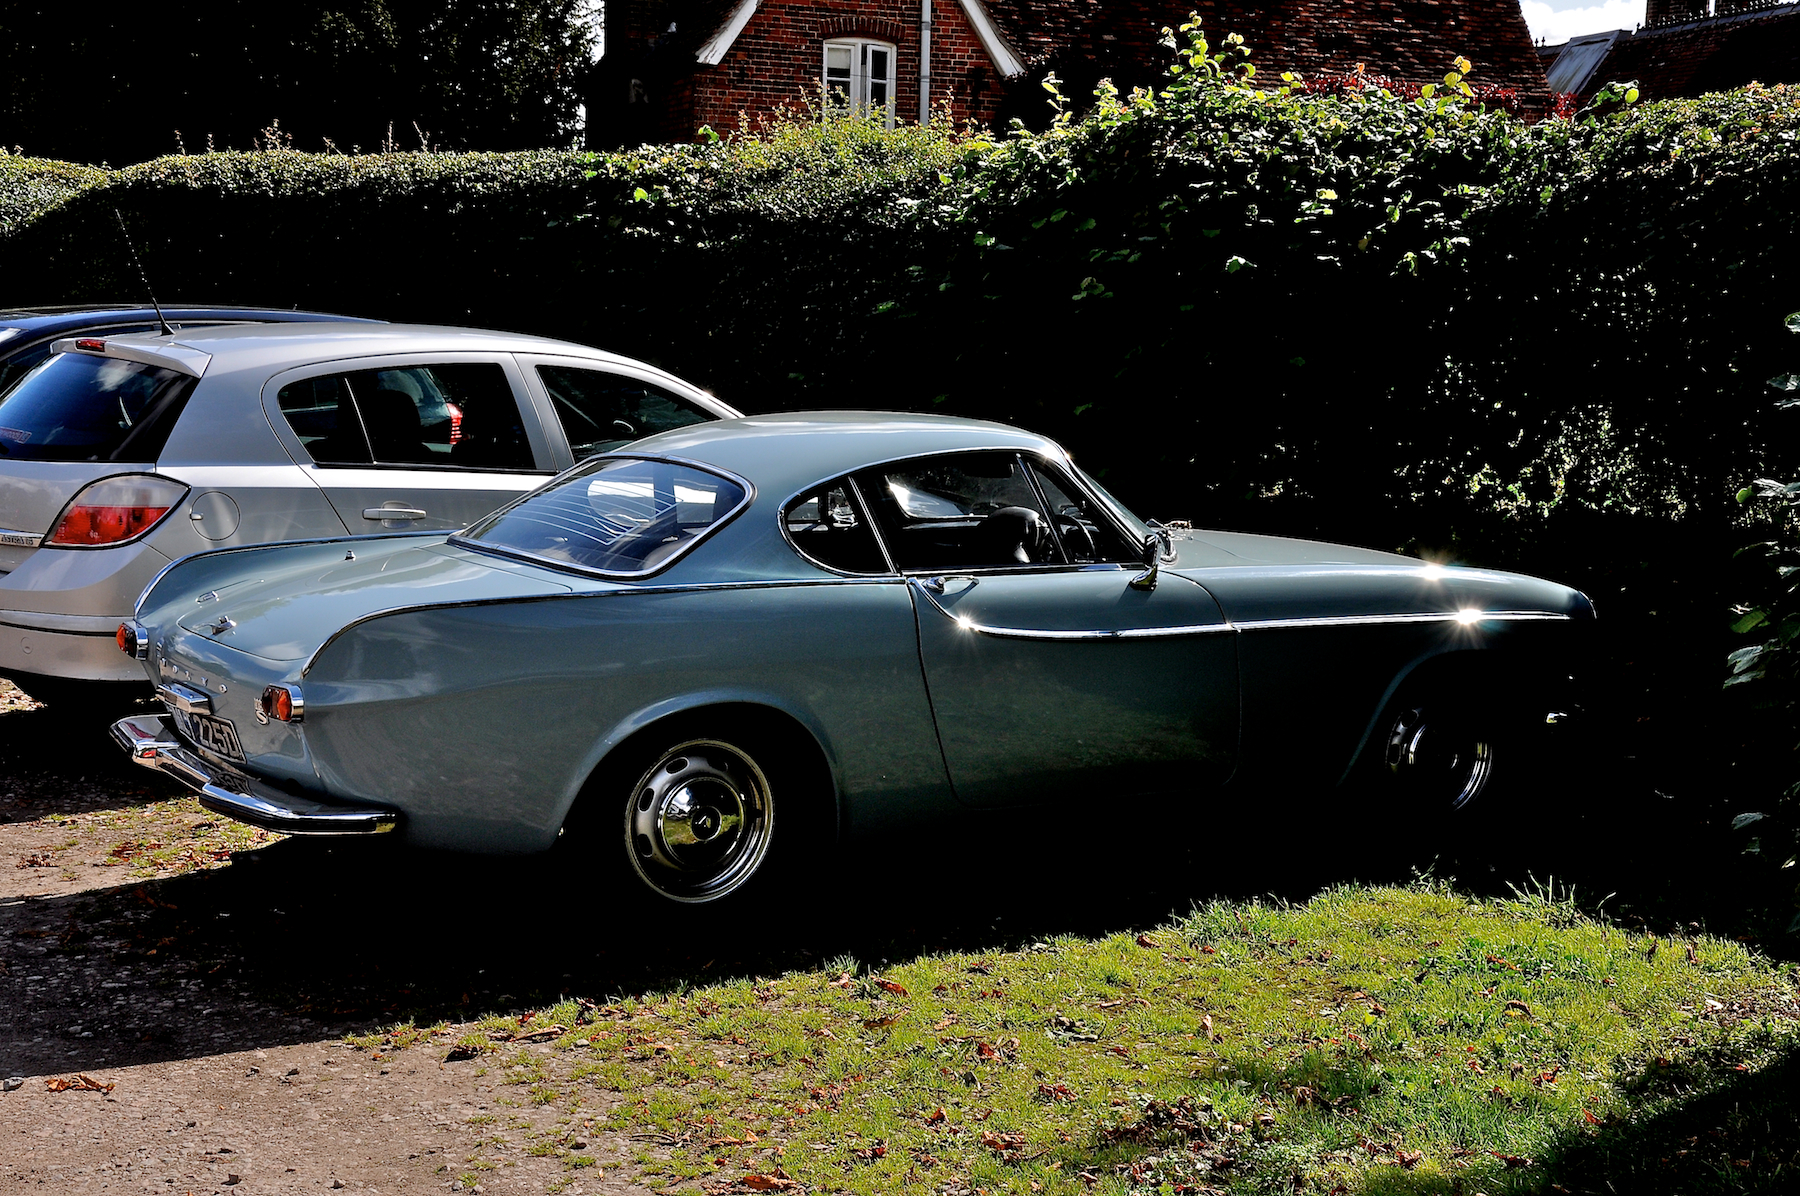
113 715 400 834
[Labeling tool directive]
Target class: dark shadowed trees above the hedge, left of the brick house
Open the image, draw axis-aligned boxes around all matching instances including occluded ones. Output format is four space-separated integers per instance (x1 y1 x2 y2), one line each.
0 0 594 164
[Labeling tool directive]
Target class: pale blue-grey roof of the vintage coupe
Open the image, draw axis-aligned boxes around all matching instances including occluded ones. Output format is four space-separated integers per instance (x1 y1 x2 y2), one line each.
621 411 1067 503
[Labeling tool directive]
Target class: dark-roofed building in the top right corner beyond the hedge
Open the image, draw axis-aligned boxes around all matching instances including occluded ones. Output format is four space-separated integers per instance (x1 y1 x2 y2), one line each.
1543 0 1800 101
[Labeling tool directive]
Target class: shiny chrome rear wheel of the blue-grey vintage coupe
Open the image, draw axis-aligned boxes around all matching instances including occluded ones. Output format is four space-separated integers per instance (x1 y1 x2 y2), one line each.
625 738 774 904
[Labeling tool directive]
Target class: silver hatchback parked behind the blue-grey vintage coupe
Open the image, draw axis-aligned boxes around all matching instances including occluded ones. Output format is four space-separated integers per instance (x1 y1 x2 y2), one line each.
0 322 740 702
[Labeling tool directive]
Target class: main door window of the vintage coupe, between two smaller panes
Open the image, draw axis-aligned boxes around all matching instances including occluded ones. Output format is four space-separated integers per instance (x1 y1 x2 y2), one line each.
857 452 1064 573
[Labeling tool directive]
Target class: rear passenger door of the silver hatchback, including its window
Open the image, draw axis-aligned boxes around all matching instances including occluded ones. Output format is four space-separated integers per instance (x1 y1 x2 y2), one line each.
263 355 554 533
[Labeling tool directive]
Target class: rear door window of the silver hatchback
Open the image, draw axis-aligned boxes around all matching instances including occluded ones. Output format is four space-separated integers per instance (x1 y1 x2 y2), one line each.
277 362 536 470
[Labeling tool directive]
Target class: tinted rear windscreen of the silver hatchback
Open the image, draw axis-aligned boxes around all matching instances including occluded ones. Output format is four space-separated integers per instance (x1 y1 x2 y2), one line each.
0 353 196 461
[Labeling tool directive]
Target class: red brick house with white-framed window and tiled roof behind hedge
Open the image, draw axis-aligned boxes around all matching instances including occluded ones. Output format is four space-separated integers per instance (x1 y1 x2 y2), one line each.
587 0 1548 148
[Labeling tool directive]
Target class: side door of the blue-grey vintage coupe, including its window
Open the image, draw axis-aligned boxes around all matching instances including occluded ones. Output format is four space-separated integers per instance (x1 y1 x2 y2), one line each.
857 452 1238 807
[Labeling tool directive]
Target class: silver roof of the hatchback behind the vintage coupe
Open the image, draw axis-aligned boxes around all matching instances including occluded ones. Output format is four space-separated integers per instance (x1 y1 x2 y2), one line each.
82 322 662 371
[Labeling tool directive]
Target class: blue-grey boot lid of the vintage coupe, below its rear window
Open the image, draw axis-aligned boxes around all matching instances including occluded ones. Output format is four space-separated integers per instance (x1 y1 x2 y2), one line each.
150 537 569 661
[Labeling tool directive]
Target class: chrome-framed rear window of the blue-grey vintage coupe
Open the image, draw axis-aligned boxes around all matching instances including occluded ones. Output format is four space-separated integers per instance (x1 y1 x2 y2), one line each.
455 458 749 575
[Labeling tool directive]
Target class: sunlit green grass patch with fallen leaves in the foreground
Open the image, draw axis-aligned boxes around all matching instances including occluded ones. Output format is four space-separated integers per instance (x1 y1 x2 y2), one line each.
360 884 1800 1194
